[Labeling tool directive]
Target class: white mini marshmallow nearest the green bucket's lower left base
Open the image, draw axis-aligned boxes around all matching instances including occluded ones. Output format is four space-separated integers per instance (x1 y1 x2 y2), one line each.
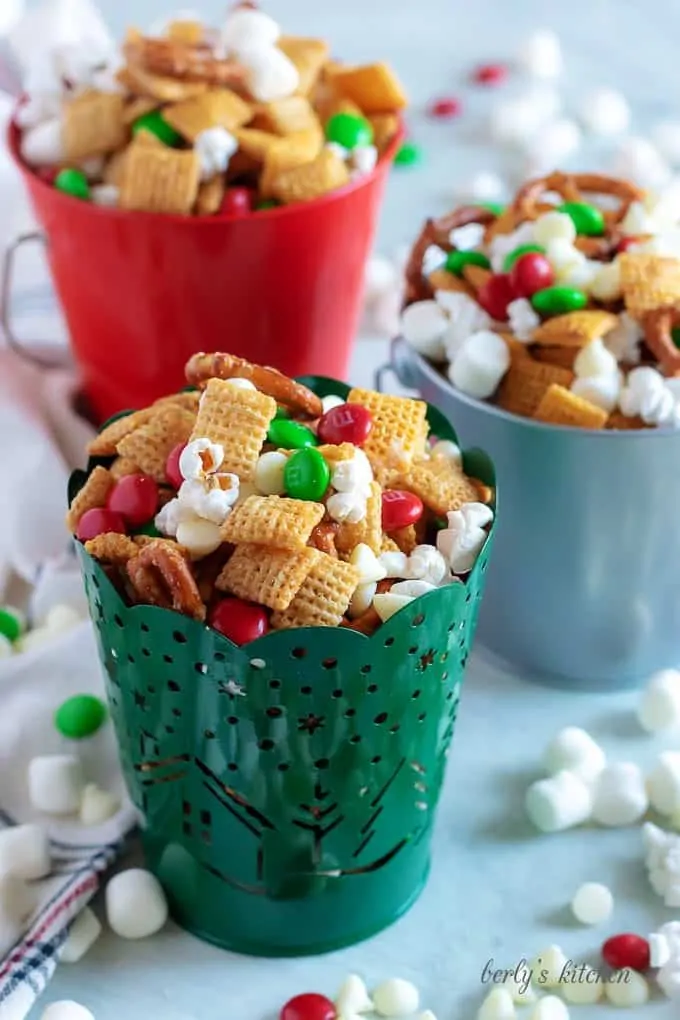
106 868 168 938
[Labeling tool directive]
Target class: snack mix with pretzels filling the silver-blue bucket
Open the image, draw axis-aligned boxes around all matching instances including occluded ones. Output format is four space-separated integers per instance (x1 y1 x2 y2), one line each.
401 172 680 429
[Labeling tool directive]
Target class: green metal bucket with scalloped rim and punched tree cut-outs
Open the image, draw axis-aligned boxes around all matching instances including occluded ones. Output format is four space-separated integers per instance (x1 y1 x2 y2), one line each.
70 378 494 957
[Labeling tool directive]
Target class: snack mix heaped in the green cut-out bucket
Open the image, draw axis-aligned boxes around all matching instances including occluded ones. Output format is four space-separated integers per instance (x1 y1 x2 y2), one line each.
67 354 494 645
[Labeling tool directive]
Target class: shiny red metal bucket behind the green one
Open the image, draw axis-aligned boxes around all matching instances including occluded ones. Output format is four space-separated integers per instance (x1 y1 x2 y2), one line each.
3 124 400 421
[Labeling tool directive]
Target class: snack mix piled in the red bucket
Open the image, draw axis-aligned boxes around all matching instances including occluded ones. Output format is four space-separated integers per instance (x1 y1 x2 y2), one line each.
16 5 407 216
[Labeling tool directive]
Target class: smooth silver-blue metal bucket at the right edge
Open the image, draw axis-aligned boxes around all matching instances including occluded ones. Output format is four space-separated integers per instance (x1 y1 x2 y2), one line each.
377 339 680 690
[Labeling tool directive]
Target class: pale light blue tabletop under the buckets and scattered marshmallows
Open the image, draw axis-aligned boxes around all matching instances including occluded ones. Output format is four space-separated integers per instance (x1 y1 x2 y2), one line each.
13 0 680 1020
